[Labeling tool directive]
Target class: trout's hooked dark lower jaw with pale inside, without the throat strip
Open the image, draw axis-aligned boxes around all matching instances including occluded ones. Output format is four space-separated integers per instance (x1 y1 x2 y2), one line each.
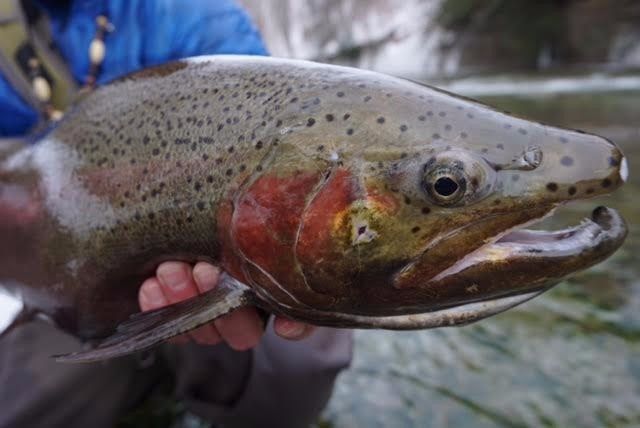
432 206 627 306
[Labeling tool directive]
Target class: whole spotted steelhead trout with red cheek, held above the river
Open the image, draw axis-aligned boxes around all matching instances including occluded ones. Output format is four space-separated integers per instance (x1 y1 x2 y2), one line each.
0 56 627 361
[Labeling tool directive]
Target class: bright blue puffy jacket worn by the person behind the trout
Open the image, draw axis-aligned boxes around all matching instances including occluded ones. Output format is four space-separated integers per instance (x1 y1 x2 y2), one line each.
0 0 267 136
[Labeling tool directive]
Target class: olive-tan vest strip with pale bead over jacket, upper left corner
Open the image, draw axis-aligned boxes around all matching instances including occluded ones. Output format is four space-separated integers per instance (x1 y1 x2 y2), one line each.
0 0 78 122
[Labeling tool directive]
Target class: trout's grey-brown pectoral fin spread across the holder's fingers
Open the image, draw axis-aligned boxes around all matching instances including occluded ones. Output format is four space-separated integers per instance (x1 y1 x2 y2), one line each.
54 275 257 363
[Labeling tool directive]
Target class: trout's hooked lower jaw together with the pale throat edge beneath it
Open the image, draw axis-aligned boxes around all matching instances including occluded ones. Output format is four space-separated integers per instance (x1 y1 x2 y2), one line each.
336 207 627 330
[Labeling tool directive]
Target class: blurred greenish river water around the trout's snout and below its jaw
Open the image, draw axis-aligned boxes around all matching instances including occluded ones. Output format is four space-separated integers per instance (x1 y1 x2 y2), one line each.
320 77 640 428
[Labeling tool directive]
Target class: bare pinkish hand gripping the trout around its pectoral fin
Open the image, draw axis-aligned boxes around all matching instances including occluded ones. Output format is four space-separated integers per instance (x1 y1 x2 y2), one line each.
138 262 314 351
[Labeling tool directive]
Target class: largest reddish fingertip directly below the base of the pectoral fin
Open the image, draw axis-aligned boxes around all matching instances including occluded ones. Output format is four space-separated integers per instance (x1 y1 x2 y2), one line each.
214 308 264 351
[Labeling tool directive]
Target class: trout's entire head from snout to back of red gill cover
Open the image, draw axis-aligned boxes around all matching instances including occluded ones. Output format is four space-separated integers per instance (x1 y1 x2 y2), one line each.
226 60 627 320
